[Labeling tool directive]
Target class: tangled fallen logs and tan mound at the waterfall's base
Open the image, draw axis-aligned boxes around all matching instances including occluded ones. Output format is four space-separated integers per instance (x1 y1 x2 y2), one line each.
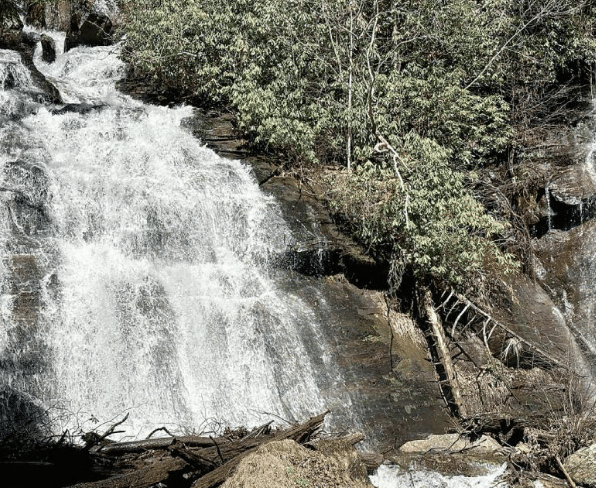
57 412 372 488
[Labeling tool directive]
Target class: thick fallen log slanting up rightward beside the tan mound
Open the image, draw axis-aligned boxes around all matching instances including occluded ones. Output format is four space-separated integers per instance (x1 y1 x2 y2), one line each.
191 411 329 488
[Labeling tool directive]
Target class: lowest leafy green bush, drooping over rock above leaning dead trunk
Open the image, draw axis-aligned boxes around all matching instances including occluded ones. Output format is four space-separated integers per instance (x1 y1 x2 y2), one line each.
333 135 515 287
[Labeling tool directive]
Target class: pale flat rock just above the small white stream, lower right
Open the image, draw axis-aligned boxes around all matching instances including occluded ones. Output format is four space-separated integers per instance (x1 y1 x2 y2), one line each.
399 434 501 455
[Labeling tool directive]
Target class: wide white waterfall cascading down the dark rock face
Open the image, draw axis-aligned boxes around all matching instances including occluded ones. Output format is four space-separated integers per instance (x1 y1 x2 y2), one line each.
0 37 350 435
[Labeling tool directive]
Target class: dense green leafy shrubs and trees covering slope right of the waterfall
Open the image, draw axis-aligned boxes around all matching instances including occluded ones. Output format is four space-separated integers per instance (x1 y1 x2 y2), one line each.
124 0 596 288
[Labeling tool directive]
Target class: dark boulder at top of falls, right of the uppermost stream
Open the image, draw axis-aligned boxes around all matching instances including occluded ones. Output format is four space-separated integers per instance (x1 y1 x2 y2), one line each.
64 12 113 52
